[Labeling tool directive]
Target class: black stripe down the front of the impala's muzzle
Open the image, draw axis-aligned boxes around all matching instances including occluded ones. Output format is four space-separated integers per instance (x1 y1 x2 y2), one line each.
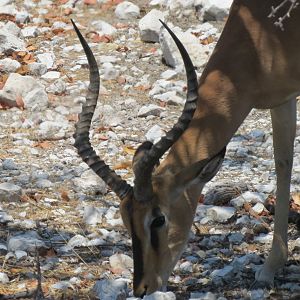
130 220 144 289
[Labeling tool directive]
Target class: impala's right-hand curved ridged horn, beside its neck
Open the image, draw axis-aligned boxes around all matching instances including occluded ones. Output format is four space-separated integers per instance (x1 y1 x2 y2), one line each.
134 20 198 200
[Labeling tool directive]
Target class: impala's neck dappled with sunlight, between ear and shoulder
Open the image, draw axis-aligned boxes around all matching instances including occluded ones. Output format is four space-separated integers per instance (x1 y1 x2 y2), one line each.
156 71 251 174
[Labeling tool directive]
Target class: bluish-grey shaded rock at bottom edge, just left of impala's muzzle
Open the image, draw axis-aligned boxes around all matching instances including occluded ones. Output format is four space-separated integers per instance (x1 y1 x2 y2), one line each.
93 279 128 300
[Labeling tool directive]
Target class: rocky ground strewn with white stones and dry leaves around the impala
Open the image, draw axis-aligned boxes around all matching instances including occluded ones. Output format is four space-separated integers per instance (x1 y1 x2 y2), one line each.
0 0 300 300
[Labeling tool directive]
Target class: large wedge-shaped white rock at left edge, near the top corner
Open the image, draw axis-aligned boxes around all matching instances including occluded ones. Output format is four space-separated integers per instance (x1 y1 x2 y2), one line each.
0 28 26 54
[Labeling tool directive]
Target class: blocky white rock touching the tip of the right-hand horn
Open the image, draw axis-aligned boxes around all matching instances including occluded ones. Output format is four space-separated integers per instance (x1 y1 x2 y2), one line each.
139 9 166 43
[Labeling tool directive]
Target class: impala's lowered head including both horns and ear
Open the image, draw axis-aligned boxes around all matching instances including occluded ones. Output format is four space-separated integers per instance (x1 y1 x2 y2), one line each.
72 21 225 296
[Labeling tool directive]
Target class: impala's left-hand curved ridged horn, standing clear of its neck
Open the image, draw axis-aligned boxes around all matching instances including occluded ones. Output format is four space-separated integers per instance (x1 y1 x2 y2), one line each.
71 20 132 200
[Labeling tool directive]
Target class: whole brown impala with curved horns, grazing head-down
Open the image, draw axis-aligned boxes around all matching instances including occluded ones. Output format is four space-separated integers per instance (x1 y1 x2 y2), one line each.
74 0 300 296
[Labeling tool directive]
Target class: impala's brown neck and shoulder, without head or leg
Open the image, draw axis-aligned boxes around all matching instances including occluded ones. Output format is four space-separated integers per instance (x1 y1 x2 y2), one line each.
156 0 300 175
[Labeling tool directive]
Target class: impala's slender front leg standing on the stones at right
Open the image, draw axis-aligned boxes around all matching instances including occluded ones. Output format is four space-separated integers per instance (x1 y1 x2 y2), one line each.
255 99 296 286
